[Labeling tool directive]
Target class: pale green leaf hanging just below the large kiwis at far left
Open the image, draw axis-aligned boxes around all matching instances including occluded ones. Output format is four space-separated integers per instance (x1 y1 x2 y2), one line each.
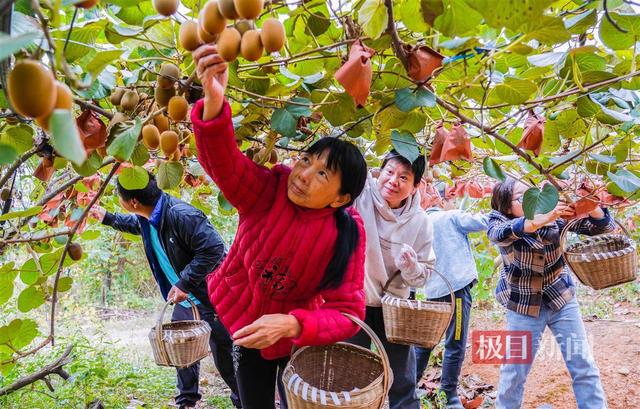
49 109 87 165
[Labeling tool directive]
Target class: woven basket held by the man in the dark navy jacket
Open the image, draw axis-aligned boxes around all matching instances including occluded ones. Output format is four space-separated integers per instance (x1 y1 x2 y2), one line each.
149 299 211 368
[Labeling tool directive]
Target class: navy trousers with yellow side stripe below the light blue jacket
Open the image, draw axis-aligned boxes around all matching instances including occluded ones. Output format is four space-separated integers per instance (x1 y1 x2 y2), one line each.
416 284 473 397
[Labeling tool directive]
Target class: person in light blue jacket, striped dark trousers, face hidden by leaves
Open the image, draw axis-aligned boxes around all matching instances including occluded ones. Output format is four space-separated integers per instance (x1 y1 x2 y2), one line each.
416 182 487 409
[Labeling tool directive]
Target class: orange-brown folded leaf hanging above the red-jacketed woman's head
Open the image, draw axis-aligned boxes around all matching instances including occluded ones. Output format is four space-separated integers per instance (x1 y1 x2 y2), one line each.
335 40 375 107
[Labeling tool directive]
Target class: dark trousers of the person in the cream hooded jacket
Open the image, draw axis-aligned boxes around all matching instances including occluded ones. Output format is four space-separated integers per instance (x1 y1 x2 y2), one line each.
348 307 420 409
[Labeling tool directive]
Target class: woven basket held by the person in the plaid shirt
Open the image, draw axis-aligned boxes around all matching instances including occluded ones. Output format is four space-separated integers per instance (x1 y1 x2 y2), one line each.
560 219 638 290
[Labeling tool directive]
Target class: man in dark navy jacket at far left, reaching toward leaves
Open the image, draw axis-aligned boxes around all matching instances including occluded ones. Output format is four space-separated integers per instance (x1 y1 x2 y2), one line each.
93 174 241 408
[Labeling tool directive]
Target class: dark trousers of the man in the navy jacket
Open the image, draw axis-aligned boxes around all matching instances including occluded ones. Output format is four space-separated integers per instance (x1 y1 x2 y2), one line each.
171 304 241 408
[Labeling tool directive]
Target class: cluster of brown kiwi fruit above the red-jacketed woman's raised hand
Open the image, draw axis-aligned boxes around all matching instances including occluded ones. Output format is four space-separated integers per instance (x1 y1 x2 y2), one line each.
154 0 285 62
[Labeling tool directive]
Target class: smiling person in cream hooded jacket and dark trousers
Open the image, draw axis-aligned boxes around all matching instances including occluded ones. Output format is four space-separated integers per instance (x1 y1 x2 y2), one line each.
350 150 435 409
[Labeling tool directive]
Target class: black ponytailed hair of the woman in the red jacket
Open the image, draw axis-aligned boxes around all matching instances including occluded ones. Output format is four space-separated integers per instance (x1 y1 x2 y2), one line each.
306 137 367 290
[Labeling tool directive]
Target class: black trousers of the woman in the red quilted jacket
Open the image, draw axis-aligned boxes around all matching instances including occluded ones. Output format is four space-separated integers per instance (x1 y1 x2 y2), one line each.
233 346 289 409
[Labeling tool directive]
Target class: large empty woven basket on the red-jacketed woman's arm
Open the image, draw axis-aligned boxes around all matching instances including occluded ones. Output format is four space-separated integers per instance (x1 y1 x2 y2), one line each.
282 314 393 409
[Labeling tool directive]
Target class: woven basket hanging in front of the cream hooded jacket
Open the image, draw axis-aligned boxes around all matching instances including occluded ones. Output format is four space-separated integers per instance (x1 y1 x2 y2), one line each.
382 270 455 349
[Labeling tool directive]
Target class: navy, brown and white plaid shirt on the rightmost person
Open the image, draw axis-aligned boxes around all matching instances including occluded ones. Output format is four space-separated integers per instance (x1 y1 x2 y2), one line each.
487 209 615 317
